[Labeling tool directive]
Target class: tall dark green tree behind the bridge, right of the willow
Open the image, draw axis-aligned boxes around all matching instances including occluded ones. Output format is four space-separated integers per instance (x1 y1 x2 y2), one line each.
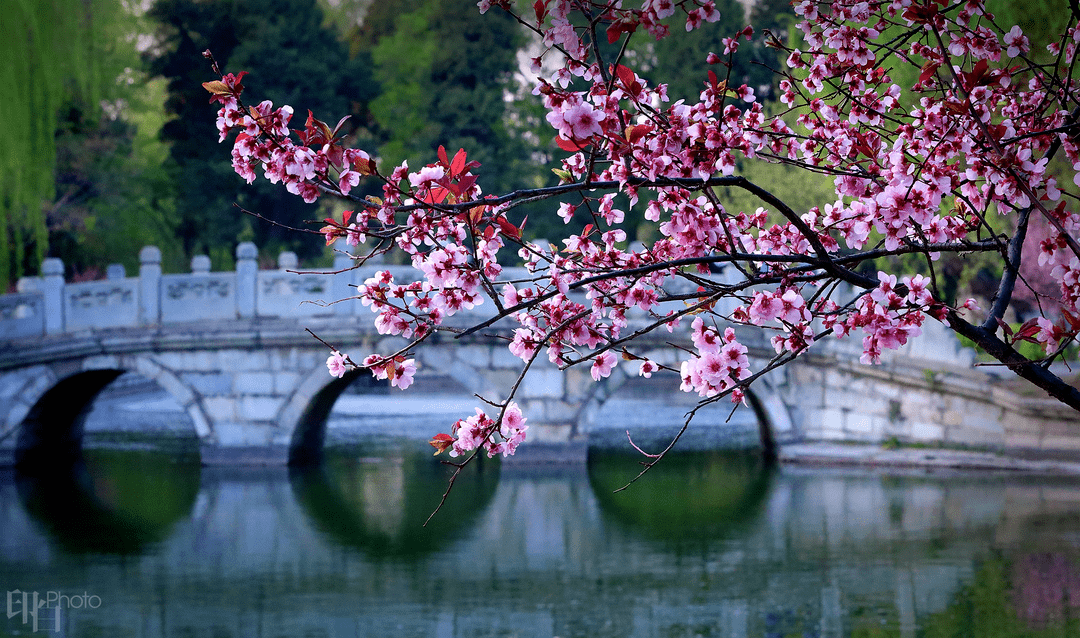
150 0 374 267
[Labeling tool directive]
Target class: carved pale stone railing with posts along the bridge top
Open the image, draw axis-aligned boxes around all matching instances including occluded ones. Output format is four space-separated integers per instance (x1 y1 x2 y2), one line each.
0 240 974 367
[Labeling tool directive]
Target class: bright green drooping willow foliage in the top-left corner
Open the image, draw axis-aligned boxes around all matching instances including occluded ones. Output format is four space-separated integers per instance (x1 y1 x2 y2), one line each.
0 0 121 288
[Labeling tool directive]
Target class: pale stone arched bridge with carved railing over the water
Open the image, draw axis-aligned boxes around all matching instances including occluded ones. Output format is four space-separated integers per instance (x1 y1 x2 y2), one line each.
0 244 1080 466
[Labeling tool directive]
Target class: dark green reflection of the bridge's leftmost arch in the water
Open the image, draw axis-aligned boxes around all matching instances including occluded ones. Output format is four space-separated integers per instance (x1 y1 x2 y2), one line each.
15 450 199 555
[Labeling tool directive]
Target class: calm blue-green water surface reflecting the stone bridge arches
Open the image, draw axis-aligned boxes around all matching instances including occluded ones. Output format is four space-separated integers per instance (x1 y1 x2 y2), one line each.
0 440 1080 637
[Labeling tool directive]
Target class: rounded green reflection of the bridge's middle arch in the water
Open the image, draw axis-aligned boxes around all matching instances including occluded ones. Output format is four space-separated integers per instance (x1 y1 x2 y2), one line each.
289 440 499 558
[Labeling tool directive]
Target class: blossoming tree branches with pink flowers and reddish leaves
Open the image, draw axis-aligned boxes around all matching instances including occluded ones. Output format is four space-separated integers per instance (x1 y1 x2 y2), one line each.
205 0 1080 472
